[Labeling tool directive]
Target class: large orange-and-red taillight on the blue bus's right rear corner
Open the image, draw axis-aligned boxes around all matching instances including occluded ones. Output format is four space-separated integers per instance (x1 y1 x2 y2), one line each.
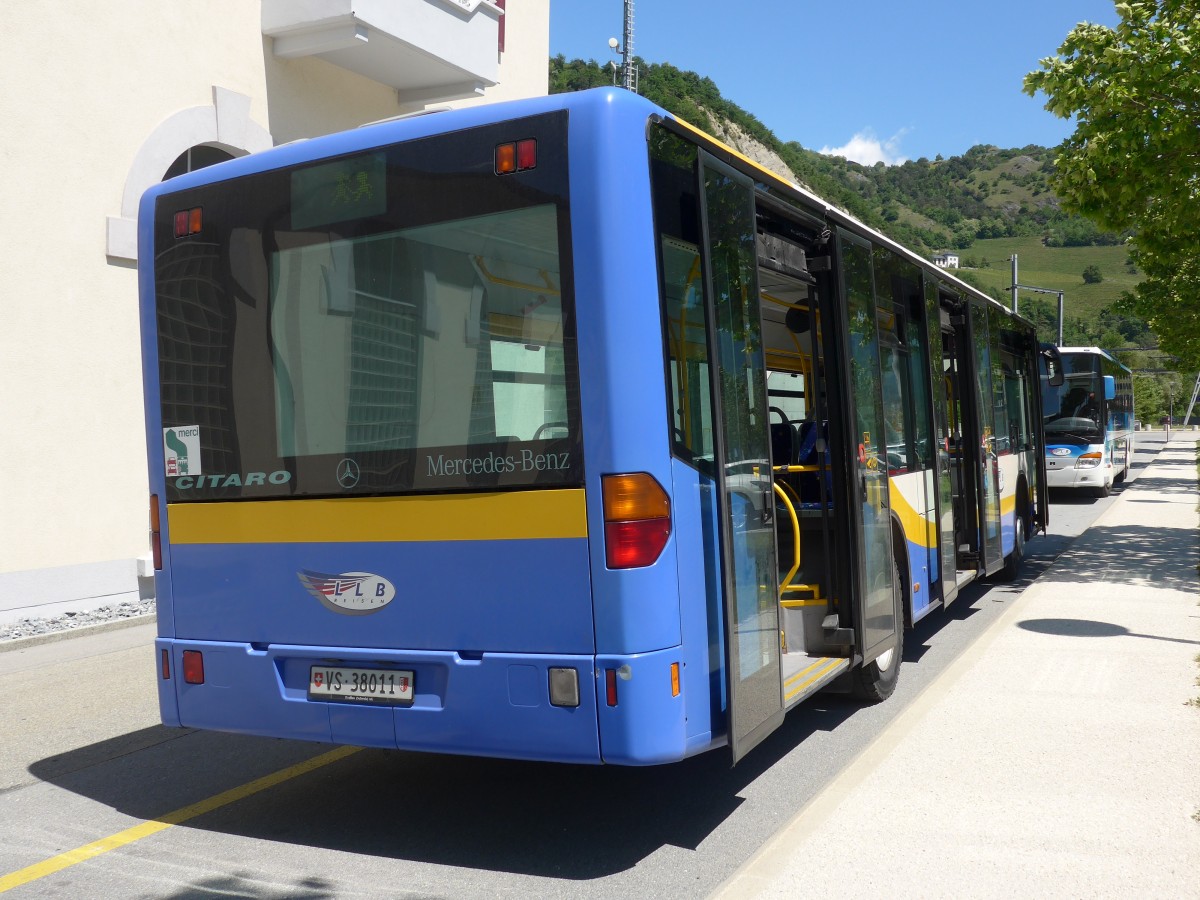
602 472 671 569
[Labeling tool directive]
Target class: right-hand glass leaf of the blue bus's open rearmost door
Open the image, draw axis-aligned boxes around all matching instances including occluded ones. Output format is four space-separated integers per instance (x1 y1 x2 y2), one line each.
839 236 899 664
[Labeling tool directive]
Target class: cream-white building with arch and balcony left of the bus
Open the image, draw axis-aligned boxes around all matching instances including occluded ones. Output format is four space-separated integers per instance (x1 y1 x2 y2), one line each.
0 0 550 608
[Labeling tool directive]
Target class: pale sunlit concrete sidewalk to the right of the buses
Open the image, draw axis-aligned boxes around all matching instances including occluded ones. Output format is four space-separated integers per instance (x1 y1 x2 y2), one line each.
715 444 1200 899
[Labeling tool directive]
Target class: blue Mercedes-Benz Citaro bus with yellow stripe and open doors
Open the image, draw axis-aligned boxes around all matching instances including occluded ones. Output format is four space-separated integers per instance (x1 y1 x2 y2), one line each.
139 89 1048 764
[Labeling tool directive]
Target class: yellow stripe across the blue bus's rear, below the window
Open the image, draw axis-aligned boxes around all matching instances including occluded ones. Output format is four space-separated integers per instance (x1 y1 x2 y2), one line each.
167 488 588 544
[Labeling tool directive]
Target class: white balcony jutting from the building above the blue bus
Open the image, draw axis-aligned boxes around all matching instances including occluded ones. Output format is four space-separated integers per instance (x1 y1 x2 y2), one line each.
263 0 503 106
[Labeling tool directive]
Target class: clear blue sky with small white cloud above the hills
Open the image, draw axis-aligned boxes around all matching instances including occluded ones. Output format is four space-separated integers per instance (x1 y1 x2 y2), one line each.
550 0 1118 164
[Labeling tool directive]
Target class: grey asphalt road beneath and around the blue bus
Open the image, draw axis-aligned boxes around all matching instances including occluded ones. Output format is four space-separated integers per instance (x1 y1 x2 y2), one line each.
0 432 1164 900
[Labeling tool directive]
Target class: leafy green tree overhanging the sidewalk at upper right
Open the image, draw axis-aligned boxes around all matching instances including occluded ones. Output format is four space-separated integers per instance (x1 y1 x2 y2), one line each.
1025 0 1200 370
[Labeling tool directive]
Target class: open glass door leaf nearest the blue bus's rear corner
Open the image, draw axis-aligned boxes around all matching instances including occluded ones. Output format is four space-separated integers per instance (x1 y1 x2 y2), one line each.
701 154 784 762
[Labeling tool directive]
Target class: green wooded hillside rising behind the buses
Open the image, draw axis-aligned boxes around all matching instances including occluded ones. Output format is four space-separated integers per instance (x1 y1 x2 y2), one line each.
550 56 1154 360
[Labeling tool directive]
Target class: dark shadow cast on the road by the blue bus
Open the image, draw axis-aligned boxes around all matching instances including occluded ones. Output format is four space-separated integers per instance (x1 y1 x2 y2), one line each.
29 696 860 880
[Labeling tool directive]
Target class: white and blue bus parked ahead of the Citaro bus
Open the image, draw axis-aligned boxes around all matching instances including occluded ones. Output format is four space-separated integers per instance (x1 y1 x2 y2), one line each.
1042 347 1134 497
